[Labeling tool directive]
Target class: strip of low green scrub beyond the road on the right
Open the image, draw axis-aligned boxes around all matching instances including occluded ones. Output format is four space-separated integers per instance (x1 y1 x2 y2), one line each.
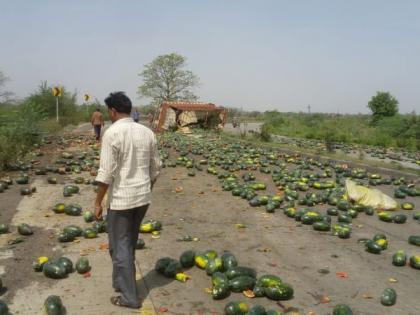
262 111 420 150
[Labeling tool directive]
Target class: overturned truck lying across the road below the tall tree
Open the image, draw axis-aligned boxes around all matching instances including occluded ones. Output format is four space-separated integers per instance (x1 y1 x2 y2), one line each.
153 102 227 132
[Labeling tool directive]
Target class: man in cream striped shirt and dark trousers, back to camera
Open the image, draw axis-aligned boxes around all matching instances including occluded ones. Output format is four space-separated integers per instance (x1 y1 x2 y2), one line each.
95 92 161 308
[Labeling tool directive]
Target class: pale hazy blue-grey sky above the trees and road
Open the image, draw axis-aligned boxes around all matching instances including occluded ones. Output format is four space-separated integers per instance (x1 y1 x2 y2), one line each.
0 0 420 113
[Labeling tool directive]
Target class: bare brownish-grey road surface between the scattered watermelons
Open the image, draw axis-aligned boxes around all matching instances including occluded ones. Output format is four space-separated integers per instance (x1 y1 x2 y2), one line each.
0 127 420 315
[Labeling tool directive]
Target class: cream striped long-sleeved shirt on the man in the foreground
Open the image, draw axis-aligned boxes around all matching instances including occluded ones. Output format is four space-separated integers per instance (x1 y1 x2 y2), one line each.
96 118 161 210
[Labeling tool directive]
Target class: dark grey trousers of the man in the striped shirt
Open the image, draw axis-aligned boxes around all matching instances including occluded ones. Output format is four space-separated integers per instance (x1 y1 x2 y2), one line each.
107 205 149 307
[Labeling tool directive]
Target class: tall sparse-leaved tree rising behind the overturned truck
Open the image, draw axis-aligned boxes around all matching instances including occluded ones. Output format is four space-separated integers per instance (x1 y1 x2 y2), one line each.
138 53 199 104
